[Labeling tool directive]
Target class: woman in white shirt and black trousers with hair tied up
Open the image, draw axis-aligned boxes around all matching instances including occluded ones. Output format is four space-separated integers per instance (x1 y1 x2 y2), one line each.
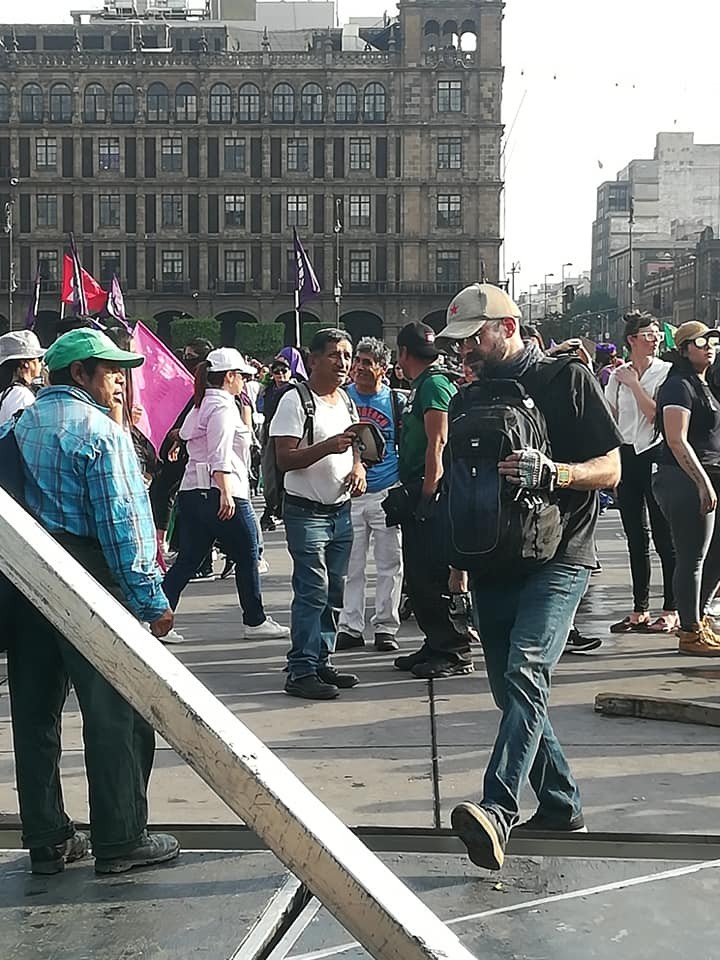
605 312 678 633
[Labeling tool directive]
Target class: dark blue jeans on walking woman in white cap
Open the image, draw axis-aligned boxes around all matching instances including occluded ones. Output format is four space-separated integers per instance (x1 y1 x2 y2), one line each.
163 488 265 627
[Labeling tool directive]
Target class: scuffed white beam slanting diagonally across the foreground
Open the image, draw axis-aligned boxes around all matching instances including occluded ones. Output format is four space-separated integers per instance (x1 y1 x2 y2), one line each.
0 489 472 960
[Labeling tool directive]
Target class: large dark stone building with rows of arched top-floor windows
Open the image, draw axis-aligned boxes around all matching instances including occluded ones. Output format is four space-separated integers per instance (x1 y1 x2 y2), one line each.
0 0 503 342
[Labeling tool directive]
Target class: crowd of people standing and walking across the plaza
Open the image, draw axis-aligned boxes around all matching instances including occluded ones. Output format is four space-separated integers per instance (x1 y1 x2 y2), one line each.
0 283 720 873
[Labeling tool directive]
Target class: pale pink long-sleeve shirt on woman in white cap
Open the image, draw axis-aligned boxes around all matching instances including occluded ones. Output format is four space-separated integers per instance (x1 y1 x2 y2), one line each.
180 387 251 500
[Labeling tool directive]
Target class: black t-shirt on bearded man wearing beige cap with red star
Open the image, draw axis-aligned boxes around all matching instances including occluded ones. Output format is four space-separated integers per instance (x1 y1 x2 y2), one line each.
523 361 622 569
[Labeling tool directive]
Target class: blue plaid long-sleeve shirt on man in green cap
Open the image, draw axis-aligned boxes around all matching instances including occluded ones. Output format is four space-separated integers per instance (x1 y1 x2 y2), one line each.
8 386 169 623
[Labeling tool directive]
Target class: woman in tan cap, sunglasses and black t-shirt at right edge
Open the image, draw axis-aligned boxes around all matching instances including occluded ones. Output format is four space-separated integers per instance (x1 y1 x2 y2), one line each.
653 320 720 657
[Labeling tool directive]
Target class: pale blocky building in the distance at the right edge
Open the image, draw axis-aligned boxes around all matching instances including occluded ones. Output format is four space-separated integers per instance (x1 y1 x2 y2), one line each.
592 133 720 306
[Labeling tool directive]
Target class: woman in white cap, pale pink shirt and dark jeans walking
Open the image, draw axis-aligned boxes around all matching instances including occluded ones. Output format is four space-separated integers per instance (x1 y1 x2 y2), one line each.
163 347 290 640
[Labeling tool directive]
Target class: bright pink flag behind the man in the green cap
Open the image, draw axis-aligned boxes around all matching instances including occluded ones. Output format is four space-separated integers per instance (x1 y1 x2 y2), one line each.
133 322 195 451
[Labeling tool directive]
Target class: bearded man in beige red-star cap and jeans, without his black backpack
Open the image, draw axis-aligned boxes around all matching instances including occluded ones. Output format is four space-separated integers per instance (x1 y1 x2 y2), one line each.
439 283 620 870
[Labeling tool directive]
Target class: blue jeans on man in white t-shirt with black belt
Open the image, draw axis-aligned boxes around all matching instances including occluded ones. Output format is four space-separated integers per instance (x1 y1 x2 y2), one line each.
283 501 352 679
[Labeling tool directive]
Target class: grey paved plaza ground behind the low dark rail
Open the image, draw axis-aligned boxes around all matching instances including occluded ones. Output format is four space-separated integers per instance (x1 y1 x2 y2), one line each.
0 512 720 833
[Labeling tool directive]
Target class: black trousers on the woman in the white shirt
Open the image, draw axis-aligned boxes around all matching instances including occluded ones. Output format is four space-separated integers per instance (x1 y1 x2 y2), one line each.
618 443 675 613
